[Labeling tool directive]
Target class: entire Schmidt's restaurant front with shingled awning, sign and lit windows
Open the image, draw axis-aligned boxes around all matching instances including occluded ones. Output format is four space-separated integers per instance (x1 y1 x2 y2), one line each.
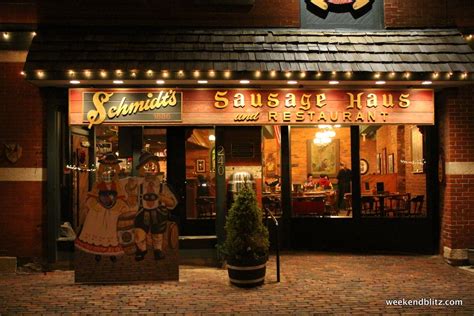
0 0 474 272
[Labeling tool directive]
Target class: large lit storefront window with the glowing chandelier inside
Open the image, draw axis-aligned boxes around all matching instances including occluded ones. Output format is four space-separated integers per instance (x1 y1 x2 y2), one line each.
291 125 352 218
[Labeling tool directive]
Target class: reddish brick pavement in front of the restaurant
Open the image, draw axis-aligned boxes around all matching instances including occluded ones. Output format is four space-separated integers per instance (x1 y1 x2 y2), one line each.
0 252 474 315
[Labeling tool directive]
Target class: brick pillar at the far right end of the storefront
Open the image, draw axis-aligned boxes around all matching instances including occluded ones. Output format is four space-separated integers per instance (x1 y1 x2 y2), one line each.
437 86 474 262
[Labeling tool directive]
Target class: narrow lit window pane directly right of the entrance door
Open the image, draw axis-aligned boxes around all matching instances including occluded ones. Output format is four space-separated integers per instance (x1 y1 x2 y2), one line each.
262 125 282 216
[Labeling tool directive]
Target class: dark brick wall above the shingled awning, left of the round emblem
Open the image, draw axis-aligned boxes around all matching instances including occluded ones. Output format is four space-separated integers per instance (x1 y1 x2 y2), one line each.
39 0 300 27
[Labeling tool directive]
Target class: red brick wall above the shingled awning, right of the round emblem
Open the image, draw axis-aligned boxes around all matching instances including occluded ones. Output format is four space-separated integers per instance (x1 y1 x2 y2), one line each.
384 0 474 28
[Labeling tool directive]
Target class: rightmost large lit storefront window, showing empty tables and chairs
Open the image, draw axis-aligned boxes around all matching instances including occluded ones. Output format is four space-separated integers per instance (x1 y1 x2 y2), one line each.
359 125 426 218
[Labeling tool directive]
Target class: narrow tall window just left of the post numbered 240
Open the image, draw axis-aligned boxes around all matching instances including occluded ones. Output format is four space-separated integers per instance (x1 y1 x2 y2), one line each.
186 128 216 219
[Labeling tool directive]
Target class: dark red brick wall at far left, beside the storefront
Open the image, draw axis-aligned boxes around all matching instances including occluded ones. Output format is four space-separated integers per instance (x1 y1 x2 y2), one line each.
0 62 46 257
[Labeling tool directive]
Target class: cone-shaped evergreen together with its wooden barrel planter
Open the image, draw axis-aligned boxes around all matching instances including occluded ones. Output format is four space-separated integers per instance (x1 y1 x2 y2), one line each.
220 186 269 287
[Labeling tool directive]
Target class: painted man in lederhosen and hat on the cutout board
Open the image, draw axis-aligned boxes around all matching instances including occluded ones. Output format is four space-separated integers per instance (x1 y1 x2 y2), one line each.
135 152 178 261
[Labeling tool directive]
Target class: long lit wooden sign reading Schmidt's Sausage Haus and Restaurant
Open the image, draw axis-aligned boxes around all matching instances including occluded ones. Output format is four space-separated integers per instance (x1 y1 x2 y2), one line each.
69 88 434 128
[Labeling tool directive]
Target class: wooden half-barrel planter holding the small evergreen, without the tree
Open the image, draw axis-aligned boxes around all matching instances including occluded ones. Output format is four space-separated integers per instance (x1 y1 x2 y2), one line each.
227 260 267 287
